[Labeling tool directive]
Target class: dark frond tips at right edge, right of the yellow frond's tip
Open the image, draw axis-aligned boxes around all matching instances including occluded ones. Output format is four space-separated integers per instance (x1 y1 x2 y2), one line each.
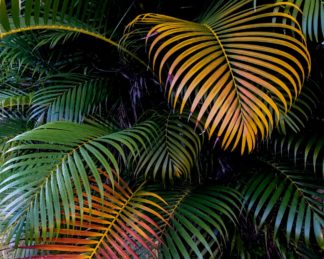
269 134 324 178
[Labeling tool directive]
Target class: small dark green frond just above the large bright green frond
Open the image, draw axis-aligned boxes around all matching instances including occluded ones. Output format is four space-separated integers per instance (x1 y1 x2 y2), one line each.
31 73 108 122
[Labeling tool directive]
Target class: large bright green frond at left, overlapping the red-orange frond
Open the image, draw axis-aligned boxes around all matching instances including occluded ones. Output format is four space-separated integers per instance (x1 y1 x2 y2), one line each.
0 122 158 245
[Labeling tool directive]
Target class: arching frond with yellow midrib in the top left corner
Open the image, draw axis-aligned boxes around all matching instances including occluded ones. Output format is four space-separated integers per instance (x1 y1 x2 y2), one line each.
0 0 143 63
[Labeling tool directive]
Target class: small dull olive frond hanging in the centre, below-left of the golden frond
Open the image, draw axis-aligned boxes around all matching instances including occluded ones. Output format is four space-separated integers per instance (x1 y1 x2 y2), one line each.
133 113 202 183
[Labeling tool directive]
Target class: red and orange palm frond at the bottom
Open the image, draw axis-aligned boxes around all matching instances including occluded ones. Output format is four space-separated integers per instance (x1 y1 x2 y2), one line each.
17 171 167 258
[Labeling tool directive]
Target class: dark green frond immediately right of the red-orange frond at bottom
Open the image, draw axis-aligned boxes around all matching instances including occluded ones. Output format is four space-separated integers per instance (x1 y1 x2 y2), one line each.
149 186 241 258
